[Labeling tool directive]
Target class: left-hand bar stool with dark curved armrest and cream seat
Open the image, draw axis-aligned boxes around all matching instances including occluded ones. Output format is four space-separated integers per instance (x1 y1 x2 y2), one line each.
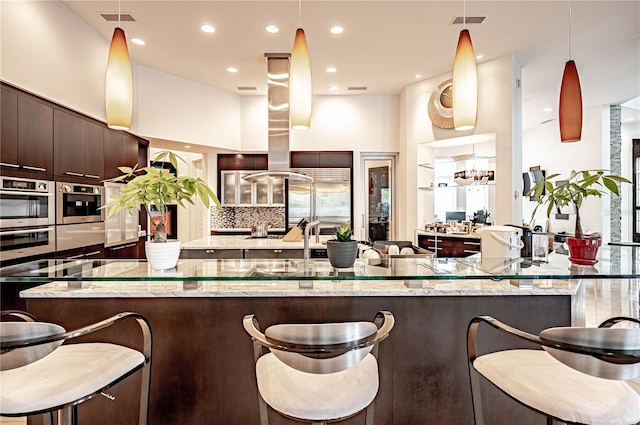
0 310 153 425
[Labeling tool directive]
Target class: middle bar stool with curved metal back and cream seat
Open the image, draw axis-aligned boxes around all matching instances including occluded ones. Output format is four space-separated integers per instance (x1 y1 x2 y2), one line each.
243 311 394 425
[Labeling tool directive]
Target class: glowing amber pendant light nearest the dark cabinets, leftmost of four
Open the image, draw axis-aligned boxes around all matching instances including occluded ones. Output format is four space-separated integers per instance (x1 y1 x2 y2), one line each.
105 2 133 130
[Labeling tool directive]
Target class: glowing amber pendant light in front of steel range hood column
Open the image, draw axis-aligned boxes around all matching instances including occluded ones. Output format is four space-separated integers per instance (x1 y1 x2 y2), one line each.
289 1 313 130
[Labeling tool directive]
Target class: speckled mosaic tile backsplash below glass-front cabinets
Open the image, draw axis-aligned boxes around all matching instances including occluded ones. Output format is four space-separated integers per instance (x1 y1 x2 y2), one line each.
211 207 285 229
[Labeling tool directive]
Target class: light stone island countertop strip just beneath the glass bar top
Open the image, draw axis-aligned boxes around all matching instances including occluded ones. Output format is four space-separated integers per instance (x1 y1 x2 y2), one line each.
21 279 580 298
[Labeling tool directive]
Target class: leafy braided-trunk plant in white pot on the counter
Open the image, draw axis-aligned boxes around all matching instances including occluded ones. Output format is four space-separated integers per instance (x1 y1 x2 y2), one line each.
103 151 222 270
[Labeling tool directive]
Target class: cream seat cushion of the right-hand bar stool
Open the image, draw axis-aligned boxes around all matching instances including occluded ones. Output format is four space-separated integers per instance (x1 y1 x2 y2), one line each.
473 350 640 425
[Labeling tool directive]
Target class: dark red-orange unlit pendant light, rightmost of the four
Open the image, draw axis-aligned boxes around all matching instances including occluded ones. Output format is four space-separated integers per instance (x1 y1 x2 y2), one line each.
558 3 582 143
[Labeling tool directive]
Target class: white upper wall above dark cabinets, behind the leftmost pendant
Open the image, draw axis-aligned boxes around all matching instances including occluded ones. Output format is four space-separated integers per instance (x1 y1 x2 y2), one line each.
0 1 241 149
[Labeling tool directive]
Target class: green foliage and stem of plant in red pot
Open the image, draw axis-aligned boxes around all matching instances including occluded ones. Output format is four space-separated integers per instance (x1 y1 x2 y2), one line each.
528 170 631 238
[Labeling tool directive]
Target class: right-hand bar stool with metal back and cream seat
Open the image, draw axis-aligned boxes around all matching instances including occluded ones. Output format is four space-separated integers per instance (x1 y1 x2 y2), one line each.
467 316 640 425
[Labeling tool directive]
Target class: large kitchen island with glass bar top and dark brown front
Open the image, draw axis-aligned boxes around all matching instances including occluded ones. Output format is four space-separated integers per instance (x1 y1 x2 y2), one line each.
6 247 640 425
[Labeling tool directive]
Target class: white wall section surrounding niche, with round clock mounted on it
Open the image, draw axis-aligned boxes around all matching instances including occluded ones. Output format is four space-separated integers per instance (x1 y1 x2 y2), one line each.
399 56 522 239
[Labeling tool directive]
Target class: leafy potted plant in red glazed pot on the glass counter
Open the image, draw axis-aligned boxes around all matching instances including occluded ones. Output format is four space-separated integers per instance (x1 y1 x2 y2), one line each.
528 170 631 265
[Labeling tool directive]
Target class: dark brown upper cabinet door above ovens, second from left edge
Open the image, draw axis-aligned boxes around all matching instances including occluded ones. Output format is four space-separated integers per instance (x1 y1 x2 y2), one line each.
18 96 53 174
